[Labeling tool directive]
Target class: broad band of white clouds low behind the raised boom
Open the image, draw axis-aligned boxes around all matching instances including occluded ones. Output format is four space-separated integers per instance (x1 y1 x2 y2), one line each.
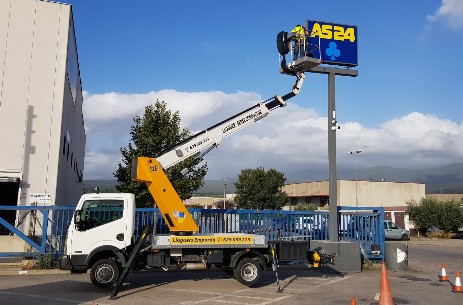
84 90 463 179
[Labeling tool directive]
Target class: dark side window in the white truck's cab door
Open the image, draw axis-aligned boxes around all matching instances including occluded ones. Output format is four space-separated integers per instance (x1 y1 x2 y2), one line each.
79 199 124 231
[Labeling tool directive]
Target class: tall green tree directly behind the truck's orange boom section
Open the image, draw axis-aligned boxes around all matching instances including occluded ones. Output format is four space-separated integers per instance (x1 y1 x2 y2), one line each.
114 100 207 207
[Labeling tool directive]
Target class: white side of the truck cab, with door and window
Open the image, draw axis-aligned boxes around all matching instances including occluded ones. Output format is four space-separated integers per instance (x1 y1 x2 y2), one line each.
68 198 133 255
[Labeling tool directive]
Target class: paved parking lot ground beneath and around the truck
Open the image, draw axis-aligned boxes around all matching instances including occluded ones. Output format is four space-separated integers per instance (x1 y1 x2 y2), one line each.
0 239 463 305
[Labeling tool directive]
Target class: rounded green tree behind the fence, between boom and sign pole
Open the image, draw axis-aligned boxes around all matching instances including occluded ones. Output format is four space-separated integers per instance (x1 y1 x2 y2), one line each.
234 167 288 210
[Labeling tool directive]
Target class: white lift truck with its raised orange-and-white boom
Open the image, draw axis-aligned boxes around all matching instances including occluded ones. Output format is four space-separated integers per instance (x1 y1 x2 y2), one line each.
59 39 333 298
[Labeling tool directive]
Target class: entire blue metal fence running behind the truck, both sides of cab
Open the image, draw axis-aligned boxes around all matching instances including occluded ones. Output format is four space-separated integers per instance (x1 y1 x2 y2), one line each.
0 206 384 259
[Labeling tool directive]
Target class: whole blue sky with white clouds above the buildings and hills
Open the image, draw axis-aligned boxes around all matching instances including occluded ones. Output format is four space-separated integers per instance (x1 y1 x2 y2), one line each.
67 0 463 180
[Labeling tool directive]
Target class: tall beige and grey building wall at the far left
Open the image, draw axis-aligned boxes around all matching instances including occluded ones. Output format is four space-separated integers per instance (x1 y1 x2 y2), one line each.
0 0 85 205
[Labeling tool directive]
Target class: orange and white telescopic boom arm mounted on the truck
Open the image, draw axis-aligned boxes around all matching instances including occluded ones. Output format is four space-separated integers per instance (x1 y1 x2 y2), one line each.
132 72 305 235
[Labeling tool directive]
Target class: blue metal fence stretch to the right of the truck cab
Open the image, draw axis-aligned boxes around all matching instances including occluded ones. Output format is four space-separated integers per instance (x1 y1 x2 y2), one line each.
136 207 384 259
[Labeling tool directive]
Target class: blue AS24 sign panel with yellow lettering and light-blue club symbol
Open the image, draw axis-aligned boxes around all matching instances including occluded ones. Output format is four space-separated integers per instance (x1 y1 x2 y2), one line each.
306 20 358 67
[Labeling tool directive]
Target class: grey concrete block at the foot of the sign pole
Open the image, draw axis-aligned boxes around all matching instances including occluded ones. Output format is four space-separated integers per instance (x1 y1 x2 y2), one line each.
310 240 362 273
